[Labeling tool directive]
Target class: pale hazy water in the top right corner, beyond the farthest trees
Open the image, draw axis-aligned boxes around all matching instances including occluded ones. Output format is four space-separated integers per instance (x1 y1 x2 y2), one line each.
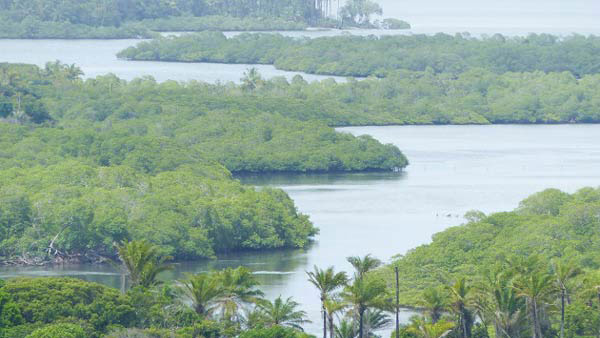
378 0 600 34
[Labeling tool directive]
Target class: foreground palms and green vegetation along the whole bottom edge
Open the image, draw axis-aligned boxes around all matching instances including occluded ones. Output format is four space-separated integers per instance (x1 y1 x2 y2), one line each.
0 232 600 338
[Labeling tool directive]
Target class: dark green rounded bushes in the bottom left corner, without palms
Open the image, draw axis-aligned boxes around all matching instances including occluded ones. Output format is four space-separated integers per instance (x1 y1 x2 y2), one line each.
0 278 135 337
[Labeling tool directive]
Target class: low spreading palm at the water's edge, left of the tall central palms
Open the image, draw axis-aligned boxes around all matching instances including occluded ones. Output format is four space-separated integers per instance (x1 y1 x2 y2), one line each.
256 296 310 331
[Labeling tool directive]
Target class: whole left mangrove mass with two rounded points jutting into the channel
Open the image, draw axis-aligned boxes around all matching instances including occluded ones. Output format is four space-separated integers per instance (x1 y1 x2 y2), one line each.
0 63 407 264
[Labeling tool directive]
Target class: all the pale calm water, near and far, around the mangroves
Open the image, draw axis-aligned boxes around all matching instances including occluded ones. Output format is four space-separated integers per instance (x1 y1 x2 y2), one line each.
0 0 600 333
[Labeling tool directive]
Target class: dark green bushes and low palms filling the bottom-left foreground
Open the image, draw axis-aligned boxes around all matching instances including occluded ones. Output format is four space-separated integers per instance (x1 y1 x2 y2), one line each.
0 268 318 338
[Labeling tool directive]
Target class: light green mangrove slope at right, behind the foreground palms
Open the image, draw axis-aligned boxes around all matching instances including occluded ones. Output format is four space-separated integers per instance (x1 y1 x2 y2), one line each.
387 188 600 304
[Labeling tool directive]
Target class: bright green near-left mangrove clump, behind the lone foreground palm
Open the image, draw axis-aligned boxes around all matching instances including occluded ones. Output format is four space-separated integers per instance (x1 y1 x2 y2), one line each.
0 161 316 262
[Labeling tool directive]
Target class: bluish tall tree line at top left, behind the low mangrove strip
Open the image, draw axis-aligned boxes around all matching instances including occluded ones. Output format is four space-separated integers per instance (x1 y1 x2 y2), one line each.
0 0 331 27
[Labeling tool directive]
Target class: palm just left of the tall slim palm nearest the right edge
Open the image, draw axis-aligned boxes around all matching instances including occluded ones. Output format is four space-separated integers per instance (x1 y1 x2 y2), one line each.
514 272 555 338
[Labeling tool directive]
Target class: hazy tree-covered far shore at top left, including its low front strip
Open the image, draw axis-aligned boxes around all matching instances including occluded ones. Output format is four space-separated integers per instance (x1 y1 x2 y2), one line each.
0 0 398 39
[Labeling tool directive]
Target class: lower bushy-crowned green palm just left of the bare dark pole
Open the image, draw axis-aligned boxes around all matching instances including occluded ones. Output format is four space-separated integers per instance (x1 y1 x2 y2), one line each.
342 276 386 338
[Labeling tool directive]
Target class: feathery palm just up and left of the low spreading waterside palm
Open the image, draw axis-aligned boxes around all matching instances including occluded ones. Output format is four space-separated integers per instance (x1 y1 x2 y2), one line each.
214 266 264 321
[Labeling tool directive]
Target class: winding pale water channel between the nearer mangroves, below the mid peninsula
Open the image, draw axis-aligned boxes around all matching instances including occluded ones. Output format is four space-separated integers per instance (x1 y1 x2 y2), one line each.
0 125 600 333
